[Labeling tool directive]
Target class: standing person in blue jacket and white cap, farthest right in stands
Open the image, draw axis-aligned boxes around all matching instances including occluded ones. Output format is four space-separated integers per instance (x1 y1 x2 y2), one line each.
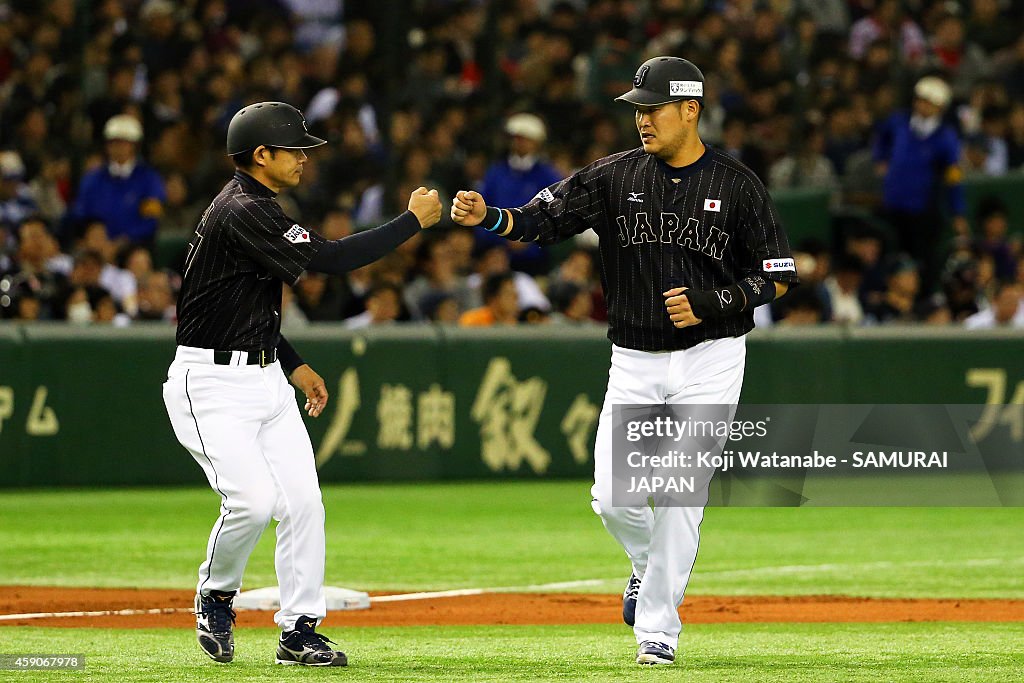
874 76 969 293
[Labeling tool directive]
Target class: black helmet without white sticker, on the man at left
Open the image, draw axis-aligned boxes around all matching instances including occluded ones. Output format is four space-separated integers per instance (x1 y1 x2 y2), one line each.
227 102 327 156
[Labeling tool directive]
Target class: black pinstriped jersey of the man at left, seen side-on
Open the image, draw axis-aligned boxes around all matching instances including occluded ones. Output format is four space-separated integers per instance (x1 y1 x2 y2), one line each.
177 172 325 351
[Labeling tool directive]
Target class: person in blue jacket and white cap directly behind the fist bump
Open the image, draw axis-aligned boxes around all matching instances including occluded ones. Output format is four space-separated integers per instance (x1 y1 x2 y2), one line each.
476 113 562 275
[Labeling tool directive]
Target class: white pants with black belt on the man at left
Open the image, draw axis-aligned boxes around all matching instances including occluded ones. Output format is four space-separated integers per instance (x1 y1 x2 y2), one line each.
164 346 327 631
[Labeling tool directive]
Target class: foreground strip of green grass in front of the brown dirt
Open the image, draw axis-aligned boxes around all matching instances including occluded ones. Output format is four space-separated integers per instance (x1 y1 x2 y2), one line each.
0 624 1024 683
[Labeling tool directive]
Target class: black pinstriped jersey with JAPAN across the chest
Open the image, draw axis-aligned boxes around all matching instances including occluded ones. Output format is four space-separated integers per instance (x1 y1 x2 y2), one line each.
512 146 799 351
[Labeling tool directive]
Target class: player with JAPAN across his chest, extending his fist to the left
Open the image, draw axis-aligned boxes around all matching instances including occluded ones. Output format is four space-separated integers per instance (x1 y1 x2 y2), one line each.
452 56 798 665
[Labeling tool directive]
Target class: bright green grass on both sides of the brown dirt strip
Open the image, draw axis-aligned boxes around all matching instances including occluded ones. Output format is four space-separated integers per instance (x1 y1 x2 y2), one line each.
0 481 1024 683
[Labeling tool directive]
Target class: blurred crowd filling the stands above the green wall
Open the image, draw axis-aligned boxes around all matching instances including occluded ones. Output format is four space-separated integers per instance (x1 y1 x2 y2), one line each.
0 0 1024 330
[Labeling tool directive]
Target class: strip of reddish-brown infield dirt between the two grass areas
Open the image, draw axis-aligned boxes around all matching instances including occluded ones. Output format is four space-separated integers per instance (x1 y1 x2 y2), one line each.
0 586 1024 629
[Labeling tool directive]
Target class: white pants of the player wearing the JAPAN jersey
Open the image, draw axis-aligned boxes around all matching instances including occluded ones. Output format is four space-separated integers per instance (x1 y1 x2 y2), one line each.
591 337 746 648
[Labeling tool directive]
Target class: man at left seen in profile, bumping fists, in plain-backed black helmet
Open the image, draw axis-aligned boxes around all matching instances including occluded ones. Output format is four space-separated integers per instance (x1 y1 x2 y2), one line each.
164 102 441 667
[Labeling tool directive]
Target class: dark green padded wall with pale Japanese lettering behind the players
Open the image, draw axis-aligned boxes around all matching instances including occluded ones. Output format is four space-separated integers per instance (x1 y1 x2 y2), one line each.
0 325 1024 486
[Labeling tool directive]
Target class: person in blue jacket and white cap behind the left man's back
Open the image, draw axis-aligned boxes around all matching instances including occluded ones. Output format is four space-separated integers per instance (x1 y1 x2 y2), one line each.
72 114 167 244
